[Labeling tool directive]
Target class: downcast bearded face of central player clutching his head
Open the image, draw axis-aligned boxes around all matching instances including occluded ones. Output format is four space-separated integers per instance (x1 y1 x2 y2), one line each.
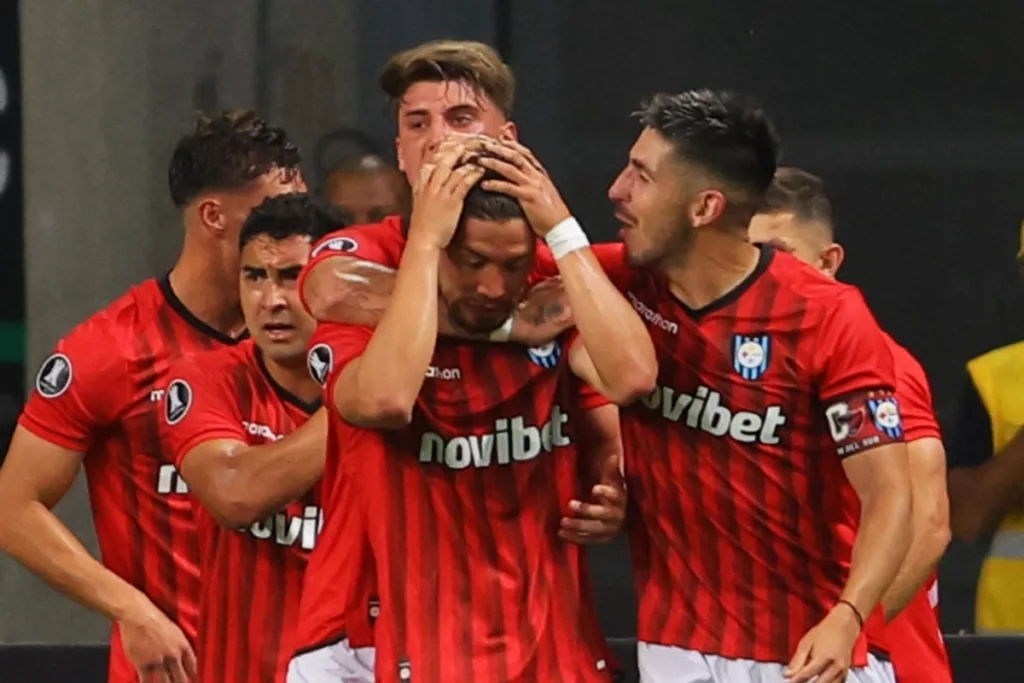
438 218 537 334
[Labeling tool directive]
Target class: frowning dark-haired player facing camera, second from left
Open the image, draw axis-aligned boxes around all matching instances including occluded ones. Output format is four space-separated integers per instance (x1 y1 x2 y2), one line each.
164 195 344 683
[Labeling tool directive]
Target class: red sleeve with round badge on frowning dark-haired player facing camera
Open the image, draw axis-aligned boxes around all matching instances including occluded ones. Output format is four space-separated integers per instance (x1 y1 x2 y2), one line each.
161 352 246 471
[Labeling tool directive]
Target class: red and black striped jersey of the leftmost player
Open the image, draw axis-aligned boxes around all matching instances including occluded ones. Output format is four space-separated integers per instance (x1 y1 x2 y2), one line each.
18 278 243 683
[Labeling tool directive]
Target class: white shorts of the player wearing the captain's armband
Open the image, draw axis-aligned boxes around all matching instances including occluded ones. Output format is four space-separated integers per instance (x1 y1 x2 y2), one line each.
637 642 896 683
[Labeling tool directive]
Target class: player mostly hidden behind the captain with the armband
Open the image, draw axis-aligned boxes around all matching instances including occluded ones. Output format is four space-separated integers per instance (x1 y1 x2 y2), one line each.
750 168 952 683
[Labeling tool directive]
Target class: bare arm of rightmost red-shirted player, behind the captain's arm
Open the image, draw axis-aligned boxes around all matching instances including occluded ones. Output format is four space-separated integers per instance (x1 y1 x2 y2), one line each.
882 437 949 621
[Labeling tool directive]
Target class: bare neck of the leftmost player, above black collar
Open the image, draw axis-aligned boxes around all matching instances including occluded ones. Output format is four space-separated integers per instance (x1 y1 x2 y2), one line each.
170 243 245 337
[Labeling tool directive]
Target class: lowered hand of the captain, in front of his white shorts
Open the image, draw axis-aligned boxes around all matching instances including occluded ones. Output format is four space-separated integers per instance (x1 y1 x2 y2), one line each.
785 604 860 683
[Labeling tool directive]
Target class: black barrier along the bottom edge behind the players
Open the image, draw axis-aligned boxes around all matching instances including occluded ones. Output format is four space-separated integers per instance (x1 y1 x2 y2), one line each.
0 636 1024 683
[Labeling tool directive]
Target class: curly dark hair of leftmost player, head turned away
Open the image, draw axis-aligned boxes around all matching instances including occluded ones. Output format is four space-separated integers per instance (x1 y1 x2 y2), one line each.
167 110 300 208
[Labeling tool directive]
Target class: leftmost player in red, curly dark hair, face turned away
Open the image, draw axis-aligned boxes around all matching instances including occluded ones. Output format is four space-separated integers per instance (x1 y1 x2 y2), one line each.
0 112 304 683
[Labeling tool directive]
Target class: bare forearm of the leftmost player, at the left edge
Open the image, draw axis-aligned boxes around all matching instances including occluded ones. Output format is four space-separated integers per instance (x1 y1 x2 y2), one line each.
0 501 148 621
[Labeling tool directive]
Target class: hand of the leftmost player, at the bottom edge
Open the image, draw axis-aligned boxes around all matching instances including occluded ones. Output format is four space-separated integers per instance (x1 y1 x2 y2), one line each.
118 603 199 683
